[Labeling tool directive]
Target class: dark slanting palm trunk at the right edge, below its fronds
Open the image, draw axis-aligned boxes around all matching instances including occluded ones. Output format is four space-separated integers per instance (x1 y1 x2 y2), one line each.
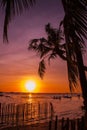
75 43 87 110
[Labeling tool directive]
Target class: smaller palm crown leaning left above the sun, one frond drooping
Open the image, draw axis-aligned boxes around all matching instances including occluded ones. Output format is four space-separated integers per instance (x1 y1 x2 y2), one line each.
28 24 66 78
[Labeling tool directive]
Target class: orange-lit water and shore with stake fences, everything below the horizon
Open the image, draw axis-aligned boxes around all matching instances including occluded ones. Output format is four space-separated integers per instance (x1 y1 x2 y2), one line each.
0 93 84 130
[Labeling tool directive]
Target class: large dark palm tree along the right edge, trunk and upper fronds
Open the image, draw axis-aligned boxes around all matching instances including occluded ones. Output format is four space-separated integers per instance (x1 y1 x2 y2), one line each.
62 0 87 109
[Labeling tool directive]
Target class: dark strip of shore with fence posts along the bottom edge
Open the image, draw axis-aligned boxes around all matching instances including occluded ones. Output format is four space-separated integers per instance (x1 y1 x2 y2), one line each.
0 116 85 130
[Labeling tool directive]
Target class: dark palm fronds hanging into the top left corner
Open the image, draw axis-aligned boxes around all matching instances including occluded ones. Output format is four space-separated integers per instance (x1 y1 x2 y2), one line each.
0 0 35 42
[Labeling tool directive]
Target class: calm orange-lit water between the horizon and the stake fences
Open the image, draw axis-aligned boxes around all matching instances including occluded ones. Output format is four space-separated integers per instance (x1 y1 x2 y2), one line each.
0 93 84 119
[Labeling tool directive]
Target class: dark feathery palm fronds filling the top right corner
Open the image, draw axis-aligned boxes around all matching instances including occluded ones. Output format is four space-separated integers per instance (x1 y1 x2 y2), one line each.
62 0 87 43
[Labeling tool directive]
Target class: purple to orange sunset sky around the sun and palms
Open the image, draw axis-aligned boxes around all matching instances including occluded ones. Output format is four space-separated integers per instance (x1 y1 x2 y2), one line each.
0 0 86 93
